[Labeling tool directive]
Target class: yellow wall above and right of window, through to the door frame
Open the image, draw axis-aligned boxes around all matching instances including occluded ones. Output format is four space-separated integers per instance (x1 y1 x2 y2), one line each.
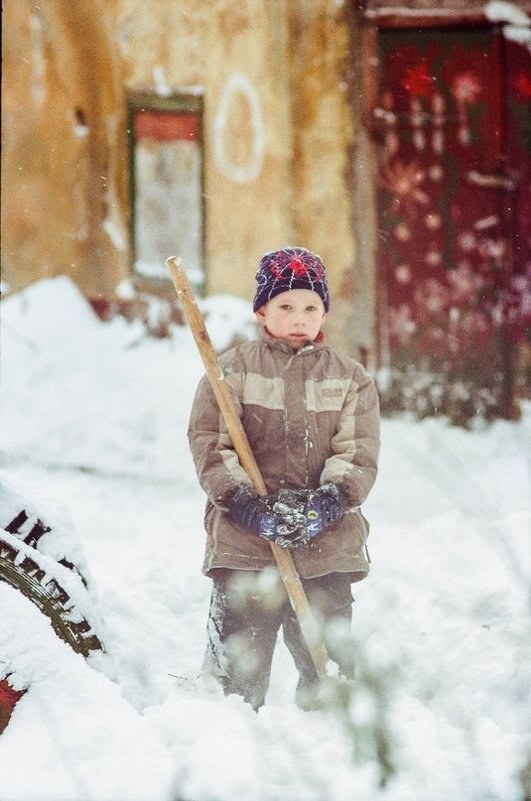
116 0 353 306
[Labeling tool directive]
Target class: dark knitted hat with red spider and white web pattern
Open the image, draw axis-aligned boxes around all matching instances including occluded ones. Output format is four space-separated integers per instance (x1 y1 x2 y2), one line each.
253 248 330 311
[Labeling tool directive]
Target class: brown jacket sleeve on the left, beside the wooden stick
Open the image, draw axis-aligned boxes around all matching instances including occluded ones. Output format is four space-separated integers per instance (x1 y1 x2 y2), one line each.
188 376 251 506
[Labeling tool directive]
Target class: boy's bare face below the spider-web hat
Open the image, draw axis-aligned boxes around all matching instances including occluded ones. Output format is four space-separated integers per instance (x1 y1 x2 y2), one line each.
256 289 326 349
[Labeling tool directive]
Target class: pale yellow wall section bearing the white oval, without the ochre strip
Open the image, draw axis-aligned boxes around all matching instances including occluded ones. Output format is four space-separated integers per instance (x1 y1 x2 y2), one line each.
116 0 292 296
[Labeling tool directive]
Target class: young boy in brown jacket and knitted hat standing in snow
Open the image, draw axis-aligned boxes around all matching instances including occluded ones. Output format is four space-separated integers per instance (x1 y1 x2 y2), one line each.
189 247 379 709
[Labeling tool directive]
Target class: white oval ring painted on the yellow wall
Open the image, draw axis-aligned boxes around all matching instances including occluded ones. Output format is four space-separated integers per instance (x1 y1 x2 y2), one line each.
214 72 265 184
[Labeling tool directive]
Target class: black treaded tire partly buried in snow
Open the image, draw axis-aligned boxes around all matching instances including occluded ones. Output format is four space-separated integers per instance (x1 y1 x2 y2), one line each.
0 536 102 656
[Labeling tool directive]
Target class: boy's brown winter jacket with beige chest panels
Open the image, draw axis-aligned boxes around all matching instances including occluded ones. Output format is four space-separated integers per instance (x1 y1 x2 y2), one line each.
188 332 379 581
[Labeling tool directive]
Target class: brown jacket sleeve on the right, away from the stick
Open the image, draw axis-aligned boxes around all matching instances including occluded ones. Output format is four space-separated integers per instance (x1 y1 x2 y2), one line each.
320 367 380 506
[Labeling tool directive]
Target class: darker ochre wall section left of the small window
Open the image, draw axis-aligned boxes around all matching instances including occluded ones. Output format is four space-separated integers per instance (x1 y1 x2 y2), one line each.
2 0 128 296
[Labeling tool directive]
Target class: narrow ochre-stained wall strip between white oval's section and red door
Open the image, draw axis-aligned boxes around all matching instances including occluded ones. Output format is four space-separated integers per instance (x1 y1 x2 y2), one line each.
289 0 355 349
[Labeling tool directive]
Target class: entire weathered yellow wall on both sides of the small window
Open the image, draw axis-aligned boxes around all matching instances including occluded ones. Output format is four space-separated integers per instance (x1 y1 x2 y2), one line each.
3 0 360 340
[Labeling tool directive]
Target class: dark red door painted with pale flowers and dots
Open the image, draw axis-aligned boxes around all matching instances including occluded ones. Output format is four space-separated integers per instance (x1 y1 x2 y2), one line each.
374 28 531 422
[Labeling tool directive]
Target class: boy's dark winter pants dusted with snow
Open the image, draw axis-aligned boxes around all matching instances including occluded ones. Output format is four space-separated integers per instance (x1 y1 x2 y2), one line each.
205 568 353 709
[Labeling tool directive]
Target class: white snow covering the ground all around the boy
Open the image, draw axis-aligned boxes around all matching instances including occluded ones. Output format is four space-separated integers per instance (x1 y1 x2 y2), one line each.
0 278 531 801
